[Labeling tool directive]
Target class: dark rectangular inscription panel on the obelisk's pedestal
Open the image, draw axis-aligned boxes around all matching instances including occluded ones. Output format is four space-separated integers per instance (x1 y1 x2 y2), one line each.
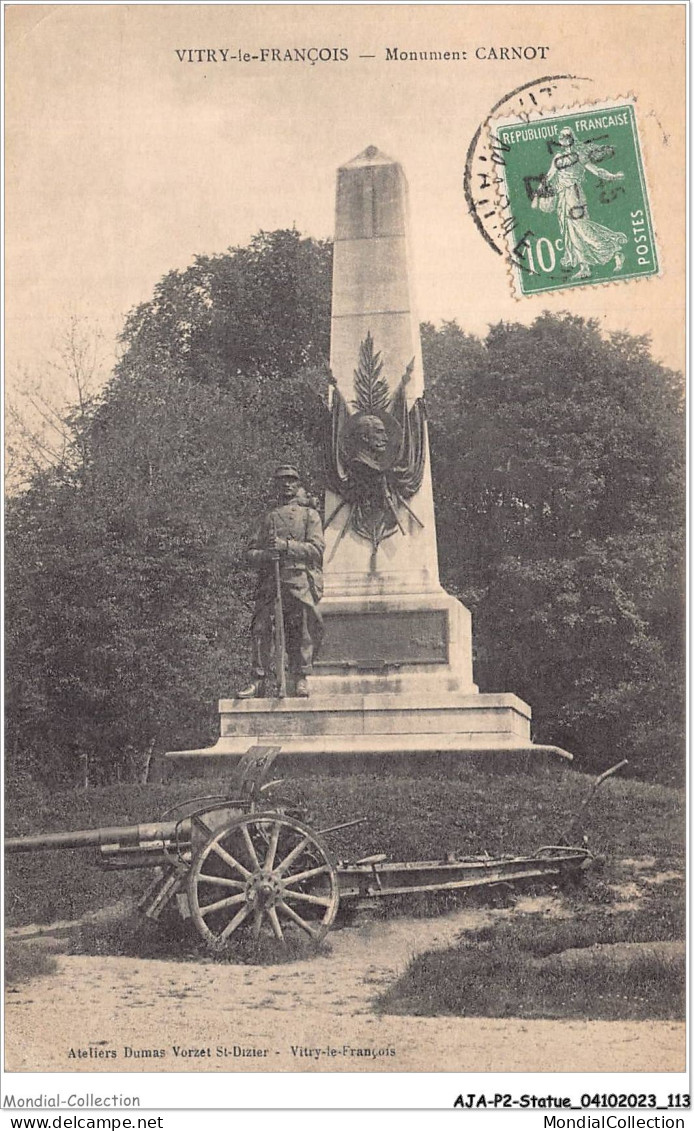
315 610 449 671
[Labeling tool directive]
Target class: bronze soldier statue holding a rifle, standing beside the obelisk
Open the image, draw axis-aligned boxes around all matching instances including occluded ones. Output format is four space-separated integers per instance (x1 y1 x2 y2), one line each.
238 466 324 699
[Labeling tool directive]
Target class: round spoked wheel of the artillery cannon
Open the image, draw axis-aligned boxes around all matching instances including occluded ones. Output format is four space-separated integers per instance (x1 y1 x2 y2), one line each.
188 813 339 949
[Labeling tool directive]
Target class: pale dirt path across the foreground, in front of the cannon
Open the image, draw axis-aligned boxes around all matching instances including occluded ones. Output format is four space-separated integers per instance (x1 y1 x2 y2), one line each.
6 897 684 1072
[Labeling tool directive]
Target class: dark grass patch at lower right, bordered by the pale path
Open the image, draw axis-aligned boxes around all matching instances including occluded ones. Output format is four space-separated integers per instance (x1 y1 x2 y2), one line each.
379 883 686 1020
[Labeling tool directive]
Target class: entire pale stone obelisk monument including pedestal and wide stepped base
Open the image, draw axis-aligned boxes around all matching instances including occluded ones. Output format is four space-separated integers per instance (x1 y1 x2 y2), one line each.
166 146 571 772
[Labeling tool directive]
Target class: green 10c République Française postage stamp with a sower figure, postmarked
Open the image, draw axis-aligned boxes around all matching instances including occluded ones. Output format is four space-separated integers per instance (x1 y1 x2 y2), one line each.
492 100 659 295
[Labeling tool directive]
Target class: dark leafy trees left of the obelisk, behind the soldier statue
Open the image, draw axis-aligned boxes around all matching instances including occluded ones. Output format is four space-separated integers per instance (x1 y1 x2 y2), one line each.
7 225 331 782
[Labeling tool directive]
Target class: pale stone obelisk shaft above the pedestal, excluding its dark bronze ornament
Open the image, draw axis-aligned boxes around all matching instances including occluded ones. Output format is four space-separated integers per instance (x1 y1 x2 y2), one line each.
324 146 440 597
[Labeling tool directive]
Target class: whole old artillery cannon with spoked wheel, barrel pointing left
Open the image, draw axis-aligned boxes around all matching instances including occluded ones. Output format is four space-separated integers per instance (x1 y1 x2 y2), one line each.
5 746 624 949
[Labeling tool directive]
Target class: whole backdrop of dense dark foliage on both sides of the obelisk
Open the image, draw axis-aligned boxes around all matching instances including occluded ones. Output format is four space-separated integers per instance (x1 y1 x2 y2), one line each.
6 231 684 783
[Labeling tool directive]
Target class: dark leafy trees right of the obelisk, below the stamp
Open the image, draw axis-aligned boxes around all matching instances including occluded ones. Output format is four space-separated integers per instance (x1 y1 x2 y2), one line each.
423 314 684 777
